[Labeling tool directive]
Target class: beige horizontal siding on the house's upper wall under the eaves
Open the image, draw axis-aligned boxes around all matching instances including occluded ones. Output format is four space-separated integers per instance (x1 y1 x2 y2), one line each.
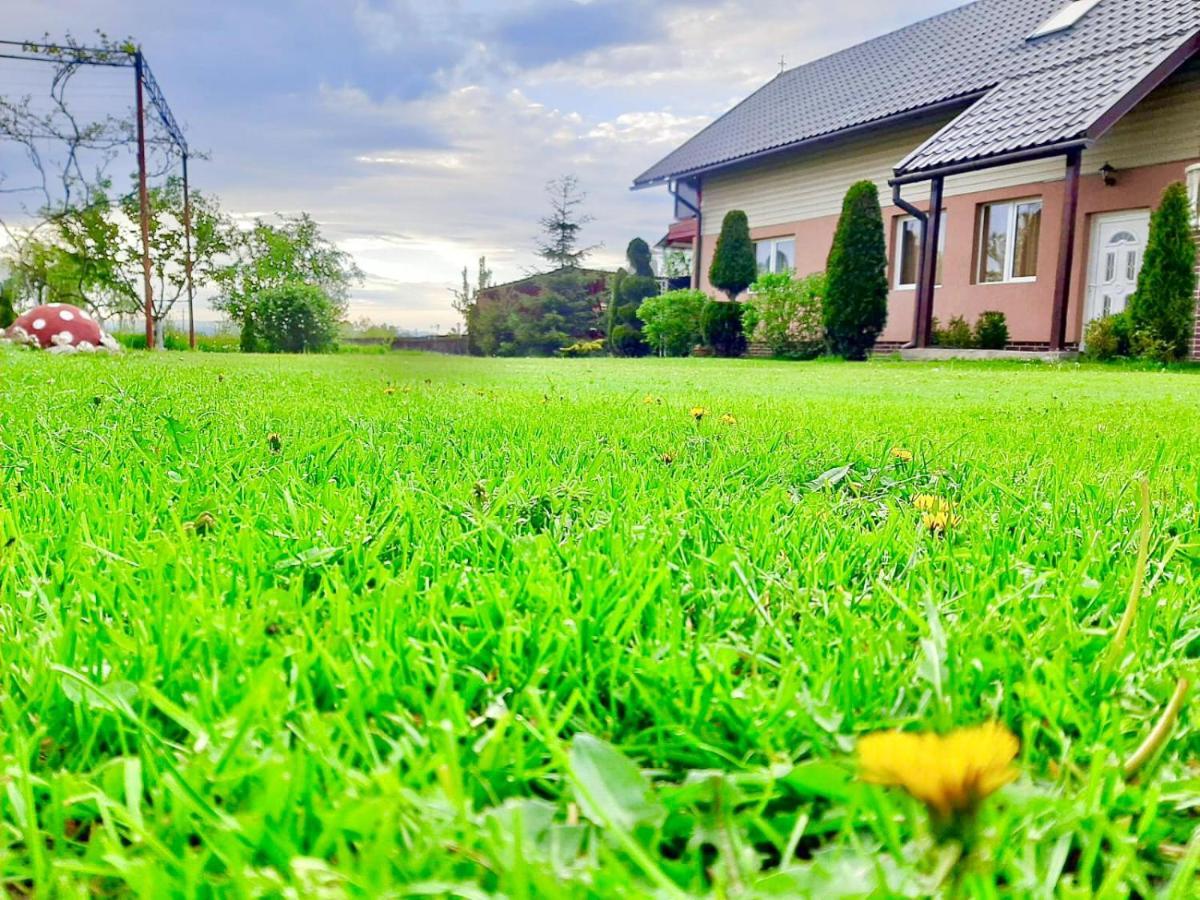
703 60 1200 234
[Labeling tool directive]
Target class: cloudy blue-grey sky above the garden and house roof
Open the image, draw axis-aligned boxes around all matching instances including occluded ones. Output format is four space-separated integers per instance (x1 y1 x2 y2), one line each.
0 0 960 329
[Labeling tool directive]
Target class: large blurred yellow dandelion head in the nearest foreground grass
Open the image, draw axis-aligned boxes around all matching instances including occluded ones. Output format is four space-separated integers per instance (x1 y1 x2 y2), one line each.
858 722 1019 821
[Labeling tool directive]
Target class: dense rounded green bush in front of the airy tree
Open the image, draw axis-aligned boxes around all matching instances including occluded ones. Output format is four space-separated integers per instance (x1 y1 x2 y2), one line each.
241 282 341 353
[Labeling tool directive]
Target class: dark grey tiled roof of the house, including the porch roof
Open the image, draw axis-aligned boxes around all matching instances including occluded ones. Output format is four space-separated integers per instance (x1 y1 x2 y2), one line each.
635 0 1200 186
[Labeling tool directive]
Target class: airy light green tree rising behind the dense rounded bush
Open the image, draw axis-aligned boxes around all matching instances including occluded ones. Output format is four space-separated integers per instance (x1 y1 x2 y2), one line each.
211 212 362 324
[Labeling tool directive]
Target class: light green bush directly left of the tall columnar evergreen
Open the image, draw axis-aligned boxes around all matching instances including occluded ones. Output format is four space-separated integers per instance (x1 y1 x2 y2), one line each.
742 272 826 359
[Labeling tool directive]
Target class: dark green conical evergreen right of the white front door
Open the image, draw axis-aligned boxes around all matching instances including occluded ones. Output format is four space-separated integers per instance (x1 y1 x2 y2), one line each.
1129 184 1196 359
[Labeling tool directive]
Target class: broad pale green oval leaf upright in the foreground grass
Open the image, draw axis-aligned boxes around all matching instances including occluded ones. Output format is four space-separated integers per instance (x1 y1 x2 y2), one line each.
570 734 662 832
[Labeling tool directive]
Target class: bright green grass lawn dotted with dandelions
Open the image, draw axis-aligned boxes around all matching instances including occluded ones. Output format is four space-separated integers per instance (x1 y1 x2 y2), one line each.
0 350 1200 898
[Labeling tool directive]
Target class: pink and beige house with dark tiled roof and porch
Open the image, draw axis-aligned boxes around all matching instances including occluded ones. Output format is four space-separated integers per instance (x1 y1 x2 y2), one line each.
635 0 1200 350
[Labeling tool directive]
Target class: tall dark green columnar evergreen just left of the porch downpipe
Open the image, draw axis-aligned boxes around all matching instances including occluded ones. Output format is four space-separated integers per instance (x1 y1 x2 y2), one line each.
824 181 888 360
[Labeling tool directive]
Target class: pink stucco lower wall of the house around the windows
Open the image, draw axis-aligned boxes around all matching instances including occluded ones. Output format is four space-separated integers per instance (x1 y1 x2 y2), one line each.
701 160 1195 343
